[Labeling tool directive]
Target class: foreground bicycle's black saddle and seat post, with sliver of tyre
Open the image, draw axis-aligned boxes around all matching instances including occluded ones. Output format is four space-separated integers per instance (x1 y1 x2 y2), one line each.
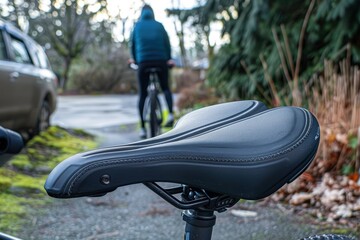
45 101 356 240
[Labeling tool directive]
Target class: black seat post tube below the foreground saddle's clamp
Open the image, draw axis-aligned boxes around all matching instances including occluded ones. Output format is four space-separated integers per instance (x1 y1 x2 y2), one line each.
182 210 216 240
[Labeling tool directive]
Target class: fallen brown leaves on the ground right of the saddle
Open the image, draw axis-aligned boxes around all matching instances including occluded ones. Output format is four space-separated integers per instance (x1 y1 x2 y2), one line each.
271 126 360 227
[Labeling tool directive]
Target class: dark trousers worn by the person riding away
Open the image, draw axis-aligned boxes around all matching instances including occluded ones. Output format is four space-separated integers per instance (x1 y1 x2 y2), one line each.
138 61 173 128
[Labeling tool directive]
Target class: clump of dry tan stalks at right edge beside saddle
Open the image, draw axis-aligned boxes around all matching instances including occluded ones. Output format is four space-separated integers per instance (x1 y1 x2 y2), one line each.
303 62 360 178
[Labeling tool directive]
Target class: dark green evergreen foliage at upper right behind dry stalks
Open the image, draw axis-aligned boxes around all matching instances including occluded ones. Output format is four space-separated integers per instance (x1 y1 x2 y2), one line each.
187 0 360 103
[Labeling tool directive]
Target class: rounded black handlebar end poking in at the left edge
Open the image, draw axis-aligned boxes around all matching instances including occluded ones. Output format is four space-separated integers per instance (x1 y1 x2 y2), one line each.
0 127 24 154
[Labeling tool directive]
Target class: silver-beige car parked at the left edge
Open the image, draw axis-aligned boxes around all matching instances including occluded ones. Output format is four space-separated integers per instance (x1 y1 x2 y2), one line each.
0 20 57 134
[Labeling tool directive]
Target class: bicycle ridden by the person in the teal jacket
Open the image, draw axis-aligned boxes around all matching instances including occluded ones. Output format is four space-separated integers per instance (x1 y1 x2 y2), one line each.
130 63 163 138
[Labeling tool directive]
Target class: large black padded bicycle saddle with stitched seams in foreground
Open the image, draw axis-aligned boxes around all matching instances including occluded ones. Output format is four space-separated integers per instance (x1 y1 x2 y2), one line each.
45 102 319 199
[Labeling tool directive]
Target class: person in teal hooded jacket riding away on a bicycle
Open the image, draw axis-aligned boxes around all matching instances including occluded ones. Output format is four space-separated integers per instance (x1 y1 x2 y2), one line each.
129 4 174 138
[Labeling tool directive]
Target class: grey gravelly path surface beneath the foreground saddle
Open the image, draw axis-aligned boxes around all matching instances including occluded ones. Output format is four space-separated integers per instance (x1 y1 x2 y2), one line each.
14 184 338 240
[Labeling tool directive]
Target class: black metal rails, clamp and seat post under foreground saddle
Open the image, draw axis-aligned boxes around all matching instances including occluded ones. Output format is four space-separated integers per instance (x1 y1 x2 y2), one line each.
144 182 239 240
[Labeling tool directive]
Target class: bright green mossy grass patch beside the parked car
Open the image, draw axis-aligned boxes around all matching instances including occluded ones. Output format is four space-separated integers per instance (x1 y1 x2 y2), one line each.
0 127 97 234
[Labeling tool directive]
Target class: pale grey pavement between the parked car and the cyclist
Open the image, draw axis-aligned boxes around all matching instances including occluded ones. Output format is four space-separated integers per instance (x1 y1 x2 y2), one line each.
51 95 139 147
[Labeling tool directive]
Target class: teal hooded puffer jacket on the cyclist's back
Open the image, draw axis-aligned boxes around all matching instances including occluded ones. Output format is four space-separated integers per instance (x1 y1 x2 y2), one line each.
131 8 171 63
